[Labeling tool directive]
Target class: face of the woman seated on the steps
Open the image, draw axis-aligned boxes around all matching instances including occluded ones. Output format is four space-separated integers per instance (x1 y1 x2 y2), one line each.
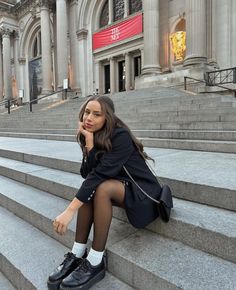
83 100 106 133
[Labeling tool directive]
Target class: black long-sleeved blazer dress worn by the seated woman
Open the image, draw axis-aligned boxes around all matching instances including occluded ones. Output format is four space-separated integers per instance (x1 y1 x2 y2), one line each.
76 128 161 228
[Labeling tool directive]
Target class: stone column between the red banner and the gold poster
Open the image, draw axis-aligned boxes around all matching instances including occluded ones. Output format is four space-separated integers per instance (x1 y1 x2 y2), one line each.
142 0 161 75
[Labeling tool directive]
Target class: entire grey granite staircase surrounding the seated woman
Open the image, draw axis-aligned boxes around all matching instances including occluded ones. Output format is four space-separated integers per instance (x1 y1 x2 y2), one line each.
0 88 236 290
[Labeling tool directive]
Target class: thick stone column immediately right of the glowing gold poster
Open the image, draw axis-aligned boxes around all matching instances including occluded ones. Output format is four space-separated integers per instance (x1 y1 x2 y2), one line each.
184 0 207 66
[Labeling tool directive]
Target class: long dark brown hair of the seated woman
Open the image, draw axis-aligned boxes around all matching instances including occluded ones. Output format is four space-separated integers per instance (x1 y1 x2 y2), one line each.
77 95 152 159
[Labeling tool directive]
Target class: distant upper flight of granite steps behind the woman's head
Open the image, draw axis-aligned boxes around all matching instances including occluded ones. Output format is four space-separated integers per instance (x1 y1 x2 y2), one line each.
0 87 236 153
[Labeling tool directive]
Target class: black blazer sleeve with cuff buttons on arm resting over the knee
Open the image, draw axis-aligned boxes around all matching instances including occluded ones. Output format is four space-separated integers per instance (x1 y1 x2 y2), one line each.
76 129 135 203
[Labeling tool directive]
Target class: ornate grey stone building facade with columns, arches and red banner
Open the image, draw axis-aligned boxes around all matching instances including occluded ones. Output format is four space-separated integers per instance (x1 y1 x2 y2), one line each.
0 0 236 102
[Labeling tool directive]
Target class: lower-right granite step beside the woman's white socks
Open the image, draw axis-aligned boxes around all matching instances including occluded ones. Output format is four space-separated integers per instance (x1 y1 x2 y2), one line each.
107 230 236 290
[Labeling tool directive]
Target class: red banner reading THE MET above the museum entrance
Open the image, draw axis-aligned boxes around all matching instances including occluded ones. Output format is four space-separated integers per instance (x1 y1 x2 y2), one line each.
93 14 143 50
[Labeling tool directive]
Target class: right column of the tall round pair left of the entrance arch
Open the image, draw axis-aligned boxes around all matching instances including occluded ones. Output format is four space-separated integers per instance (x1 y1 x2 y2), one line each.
56 0 68 88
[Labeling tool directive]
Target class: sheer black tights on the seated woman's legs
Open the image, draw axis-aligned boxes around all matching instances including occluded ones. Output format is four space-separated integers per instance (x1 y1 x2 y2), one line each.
75 179 125 251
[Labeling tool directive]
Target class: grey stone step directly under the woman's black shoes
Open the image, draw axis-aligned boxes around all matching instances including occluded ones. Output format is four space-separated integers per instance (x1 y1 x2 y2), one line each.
0 207 133 290
